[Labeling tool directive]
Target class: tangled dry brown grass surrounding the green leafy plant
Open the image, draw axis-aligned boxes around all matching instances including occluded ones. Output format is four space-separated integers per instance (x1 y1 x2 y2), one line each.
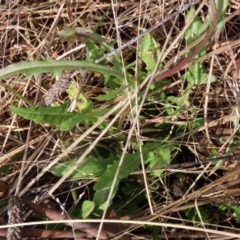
0 0 240 239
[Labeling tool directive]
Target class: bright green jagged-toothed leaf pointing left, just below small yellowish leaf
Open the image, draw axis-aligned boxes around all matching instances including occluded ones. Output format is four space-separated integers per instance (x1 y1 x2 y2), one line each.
10 102 107 131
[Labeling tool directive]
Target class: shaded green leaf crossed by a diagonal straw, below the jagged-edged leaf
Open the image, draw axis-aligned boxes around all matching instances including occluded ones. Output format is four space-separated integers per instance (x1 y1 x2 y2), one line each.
51 156 112 179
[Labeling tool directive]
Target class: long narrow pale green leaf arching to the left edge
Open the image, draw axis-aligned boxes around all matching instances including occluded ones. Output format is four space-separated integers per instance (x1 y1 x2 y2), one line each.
0 58 124 80
